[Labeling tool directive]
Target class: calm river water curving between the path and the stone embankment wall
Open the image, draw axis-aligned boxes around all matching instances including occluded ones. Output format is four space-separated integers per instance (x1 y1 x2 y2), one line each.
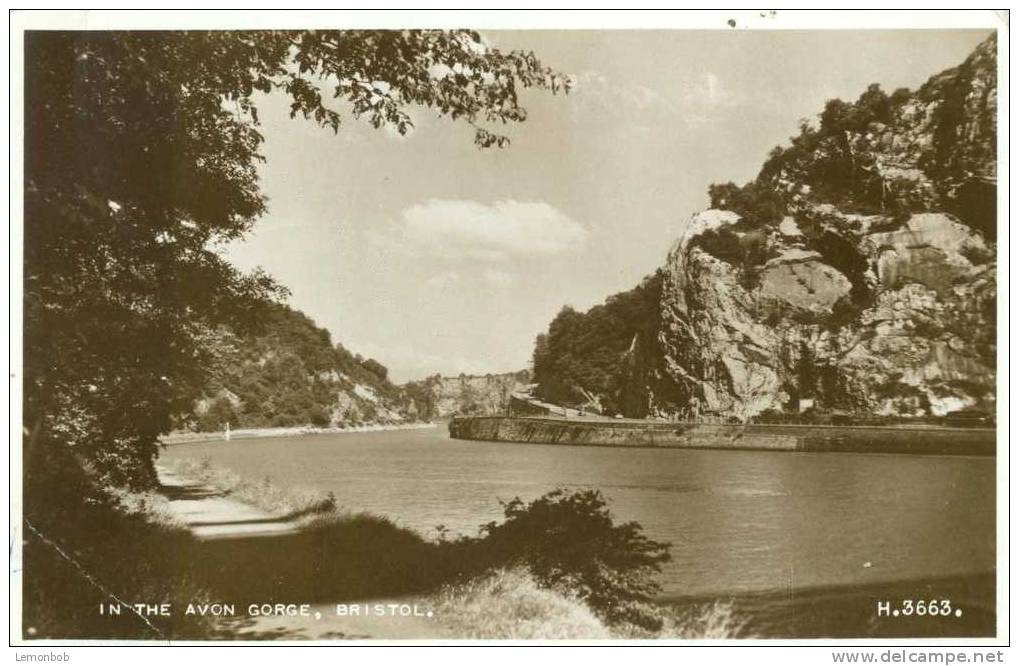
163 425 996 635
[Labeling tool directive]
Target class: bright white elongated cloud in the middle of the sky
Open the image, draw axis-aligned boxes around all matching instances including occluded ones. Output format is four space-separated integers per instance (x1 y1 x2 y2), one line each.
401 199 588 262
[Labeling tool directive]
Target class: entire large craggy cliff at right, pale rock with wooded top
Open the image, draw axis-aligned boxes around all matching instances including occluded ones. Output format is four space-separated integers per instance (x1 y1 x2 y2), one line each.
645 33 997 418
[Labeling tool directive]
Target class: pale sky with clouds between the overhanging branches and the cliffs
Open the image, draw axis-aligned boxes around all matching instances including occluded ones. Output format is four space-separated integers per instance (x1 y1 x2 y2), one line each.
223 31 988 382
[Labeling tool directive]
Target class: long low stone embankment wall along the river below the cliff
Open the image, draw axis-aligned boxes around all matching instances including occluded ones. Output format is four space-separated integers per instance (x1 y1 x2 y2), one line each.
449 417 996 455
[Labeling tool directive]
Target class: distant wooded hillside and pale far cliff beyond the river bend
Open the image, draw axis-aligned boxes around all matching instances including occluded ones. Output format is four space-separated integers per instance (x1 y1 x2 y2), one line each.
192 304 530 432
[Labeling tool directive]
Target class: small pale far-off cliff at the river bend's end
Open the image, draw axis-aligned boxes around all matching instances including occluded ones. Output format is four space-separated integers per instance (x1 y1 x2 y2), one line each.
403 371 530 419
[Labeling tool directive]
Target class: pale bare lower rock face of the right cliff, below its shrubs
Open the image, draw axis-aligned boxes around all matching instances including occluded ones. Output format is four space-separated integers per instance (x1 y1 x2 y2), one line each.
658 211 996 419
